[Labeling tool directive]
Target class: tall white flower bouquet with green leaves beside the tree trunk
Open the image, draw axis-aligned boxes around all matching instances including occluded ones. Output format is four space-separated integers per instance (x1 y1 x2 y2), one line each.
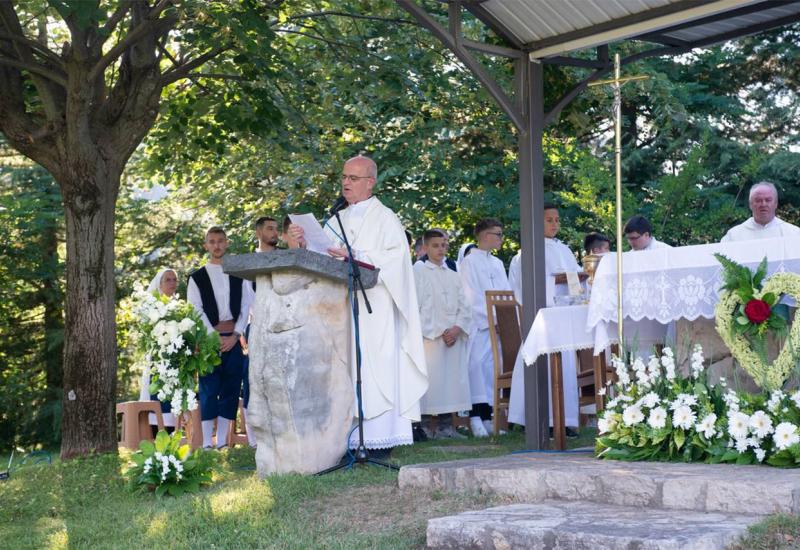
134 286 220 415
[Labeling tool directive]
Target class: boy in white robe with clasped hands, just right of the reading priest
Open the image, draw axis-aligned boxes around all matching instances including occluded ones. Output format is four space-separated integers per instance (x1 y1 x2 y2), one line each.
414 229 472 438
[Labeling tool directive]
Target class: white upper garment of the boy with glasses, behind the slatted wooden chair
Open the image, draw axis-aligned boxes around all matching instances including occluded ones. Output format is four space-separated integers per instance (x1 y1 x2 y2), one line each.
458 248 511 330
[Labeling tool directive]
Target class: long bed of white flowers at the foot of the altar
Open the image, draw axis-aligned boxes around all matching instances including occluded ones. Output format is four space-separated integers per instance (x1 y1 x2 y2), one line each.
596 346 800 467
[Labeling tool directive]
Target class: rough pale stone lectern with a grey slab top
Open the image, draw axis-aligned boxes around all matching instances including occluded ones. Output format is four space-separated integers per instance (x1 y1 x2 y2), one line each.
223 249 378 477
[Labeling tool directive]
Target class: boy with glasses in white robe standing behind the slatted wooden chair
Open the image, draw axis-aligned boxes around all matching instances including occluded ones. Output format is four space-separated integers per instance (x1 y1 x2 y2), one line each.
458 218 511 437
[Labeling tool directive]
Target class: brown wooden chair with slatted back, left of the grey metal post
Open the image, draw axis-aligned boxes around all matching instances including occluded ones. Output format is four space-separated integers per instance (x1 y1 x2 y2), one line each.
486 290 522 434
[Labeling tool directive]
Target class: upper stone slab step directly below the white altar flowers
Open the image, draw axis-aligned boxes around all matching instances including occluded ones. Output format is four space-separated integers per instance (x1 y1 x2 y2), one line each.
399 453 800 515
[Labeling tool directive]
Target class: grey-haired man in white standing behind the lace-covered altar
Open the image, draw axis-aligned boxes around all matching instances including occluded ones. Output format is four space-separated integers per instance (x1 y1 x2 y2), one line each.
721 181 800 243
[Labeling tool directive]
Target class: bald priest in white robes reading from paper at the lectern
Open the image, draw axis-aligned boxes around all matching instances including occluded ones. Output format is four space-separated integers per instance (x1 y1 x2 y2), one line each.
289 156 428 458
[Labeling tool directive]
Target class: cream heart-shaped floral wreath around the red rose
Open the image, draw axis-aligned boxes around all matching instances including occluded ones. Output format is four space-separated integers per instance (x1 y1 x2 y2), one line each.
714 273 800 391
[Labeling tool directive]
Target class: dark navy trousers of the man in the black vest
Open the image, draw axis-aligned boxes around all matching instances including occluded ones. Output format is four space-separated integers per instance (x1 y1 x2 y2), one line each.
198 334 244 420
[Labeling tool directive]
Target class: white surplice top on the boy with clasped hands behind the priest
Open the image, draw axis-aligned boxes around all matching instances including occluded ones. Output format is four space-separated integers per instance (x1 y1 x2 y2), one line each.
414 260 472 340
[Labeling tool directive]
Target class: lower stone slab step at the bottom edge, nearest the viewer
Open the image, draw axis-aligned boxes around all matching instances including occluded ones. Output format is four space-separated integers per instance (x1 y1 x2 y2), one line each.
427 500 760 550
